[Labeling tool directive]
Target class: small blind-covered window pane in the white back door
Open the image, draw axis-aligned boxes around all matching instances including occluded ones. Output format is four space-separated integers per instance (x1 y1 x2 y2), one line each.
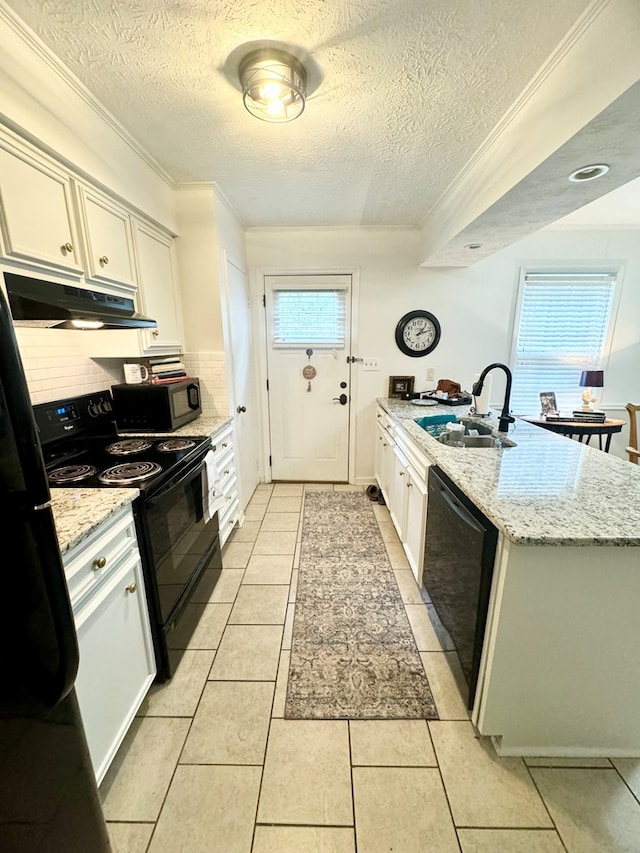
273 289 347 348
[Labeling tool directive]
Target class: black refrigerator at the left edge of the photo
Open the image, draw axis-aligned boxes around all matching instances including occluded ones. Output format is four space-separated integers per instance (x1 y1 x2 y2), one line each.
0 289 111 853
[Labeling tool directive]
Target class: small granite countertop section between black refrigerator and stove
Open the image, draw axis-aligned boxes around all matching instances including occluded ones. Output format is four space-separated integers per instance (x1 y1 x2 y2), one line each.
51 488 140 555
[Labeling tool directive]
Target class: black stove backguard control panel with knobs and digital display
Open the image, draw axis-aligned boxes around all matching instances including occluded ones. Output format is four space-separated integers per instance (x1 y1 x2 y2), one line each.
33 391 113 444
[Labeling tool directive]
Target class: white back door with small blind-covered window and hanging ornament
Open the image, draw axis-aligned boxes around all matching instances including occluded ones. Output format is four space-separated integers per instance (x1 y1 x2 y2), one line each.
265 275 351 482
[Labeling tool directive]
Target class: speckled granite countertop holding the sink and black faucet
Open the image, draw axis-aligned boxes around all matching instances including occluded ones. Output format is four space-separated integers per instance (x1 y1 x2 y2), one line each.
378 398 640 546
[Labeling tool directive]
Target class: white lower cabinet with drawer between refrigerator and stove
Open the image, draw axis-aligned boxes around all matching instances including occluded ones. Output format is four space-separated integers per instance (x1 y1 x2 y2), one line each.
64 506 156 784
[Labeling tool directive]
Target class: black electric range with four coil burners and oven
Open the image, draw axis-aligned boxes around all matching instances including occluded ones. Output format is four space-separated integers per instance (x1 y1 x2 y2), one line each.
33 390 222 681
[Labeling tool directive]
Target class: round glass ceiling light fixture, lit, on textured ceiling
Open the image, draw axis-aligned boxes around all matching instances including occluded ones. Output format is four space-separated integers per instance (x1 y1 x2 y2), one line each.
238 49 307 122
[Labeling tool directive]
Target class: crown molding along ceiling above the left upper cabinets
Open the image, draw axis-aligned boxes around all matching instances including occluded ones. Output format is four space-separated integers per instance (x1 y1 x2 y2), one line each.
0 0 175 189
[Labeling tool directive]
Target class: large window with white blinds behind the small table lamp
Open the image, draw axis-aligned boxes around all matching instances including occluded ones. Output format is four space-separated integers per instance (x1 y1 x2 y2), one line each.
511 272 617 415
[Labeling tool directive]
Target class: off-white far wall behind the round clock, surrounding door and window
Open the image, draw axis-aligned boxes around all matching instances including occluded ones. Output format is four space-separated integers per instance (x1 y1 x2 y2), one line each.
247 229 640 482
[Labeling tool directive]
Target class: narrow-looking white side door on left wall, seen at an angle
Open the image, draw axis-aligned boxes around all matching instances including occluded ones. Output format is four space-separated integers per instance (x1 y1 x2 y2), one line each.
221 259 259 509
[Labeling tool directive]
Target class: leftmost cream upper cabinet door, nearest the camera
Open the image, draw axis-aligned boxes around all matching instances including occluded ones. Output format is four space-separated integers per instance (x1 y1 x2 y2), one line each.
0 138 82 277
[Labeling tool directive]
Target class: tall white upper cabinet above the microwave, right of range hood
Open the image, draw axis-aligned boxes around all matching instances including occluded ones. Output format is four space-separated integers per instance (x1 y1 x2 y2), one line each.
134 220 182 355
